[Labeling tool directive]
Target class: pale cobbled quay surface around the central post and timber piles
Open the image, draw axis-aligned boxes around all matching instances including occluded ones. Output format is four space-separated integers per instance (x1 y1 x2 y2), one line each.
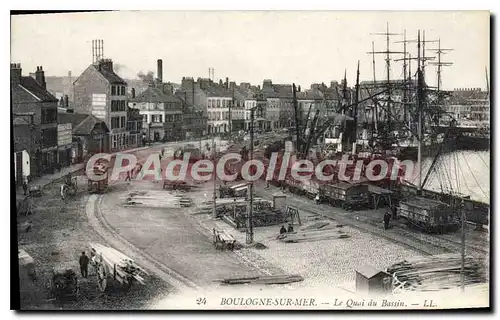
186 182 420 290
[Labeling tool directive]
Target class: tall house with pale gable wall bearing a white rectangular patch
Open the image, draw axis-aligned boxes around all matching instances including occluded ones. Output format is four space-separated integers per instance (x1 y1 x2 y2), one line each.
73 59 141 151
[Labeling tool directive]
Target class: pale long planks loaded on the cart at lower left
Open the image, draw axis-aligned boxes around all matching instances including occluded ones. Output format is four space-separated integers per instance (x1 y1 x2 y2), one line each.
90 243 147 284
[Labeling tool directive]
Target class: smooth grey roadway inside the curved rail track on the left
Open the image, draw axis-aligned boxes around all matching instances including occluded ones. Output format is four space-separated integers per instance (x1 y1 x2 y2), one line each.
100 181 268 286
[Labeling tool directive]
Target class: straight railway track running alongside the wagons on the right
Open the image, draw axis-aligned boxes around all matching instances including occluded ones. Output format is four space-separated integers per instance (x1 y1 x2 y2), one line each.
259 189 489 256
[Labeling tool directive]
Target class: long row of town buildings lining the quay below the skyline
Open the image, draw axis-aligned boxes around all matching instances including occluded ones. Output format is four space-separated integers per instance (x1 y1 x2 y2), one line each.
11 49 489 182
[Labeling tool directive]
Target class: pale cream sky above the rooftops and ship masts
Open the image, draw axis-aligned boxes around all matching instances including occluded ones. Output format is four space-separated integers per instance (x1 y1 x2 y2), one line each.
11 11 490 89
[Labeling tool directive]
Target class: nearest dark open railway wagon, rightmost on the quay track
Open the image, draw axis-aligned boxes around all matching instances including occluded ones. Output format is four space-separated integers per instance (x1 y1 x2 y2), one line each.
398 197 460 233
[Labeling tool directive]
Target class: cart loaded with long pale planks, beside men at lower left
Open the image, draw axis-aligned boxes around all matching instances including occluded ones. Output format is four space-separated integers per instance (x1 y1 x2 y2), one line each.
90 243 147 292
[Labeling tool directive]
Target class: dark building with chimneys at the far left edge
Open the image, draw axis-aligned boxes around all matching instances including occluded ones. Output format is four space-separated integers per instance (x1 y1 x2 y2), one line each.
10 64 59 178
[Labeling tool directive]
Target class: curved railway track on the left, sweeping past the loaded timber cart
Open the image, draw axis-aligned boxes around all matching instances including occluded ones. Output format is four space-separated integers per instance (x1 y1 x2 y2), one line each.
85 195 201 292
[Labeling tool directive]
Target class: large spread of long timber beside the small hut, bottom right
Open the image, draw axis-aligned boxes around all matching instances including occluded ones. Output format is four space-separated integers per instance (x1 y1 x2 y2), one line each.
387 254 486 291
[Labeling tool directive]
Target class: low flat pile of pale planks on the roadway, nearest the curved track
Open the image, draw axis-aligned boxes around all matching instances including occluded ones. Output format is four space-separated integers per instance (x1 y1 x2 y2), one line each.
123 191 193 208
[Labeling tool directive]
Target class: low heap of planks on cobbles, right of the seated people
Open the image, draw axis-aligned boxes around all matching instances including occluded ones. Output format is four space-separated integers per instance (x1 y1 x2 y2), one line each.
277 222 350 243
